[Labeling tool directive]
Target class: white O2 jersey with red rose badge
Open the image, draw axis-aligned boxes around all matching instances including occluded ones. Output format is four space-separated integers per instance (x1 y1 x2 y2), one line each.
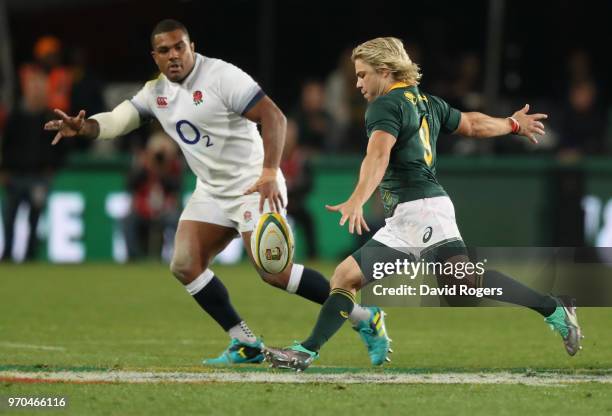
130 54 272 197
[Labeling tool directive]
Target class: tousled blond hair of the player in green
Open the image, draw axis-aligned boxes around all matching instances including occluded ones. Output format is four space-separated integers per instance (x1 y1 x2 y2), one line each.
351 37 421 85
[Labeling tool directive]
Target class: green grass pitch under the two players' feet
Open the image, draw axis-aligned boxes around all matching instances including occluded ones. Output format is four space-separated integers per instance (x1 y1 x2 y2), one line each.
0 263 612 415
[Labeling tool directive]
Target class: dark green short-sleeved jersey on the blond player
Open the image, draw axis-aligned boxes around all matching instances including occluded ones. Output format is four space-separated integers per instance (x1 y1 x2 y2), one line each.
365 83 461 217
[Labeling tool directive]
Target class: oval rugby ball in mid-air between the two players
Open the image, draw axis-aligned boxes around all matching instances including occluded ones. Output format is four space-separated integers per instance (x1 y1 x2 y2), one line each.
251 212 294 274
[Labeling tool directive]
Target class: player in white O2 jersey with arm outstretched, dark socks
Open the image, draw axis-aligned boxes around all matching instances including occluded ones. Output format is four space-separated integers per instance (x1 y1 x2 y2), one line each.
45 19 389 364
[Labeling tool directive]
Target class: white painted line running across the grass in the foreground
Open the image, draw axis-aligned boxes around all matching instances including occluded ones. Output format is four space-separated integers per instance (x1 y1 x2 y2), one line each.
0 371 612 386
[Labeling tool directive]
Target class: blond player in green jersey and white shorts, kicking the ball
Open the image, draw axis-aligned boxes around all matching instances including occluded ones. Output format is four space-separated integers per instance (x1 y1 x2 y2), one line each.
264 37 582 370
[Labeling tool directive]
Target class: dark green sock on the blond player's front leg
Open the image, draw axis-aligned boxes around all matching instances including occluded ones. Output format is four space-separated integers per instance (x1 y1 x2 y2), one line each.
302 288 355 352
